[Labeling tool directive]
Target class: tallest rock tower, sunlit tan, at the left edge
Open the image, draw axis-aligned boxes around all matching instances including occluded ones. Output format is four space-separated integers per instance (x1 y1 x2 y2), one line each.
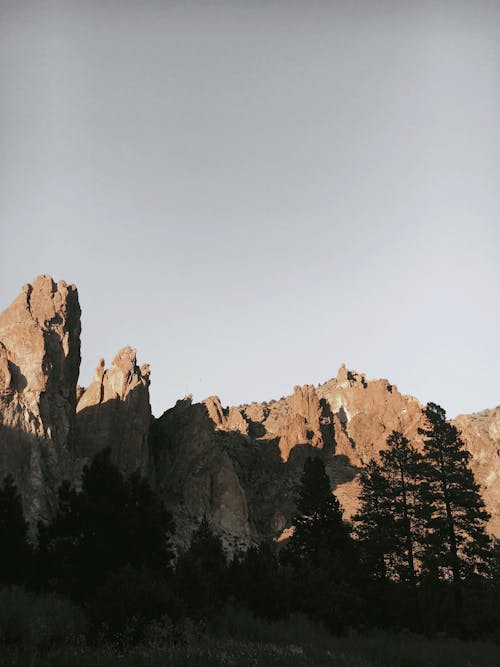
0 276 81 520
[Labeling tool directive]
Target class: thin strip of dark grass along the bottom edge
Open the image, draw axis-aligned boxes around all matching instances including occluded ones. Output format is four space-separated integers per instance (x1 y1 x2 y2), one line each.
0 633 500 667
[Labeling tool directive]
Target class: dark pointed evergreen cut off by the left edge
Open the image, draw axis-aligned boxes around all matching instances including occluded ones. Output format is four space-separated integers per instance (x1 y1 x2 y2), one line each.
0 475 31 586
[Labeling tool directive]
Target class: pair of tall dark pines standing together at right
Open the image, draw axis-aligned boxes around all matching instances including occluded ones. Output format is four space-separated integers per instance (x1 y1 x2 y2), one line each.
354 403 494 634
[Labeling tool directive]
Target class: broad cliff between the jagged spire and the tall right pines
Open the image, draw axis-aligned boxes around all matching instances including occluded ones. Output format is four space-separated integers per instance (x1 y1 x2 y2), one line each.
154 367 422 546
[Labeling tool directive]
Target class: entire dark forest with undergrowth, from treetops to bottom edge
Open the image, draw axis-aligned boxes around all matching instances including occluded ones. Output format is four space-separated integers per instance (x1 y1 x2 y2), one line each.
0 403 500 666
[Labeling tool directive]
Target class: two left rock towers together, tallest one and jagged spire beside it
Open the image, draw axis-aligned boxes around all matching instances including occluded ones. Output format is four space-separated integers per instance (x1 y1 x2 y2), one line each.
0 276 151 524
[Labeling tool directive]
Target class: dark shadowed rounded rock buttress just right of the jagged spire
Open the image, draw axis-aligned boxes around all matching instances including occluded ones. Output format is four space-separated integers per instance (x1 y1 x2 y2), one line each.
151 397 251 549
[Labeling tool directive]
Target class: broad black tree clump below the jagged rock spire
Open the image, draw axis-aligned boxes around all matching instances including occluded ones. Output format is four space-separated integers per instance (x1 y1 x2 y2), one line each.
39 449 174 600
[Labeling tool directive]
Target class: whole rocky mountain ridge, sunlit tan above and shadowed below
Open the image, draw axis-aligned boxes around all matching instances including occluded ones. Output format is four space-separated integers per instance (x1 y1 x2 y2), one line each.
0 276 500 549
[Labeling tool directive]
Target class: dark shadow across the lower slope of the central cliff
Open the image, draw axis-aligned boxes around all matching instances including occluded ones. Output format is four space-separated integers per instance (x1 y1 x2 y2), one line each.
149 399 372 552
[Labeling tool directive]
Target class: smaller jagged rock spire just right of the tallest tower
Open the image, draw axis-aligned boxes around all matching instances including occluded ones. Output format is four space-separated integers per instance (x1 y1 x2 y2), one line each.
75 347 151 476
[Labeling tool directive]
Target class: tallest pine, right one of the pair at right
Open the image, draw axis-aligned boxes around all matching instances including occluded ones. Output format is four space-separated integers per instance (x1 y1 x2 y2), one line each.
419 403 491 625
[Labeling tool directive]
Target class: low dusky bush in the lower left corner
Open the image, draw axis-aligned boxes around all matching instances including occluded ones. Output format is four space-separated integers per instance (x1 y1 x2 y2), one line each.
0 587 85 650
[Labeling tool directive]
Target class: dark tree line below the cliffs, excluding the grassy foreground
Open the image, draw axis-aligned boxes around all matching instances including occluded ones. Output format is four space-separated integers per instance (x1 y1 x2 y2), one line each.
0 403 500 641
